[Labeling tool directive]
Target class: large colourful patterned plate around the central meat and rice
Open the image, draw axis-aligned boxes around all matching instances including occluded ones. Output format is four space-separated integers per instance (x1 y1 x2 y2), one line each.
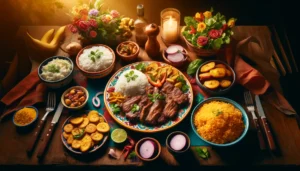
104 61 193 133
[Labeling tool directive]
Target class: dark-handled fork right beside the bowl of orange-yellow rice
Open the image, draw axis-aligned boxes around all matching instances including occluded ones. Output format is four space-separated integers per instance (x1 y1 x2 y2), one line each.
244 91 266 150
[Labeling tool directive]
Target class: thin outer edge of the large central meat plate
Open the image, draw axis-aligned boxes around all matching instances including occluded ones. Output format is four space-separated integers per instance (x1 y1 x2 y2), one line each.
103 61 194 133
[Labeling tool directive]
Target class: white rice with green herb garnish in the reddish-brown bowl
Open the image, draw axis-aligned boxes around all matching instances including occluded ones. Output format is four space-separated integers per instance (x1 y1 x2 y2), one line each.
79 46 113 72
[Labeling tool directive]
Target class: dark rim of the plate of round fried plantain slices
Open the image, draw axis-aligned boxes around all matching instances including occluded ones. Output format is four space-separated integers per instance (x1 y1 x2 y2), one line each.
60 110 109 155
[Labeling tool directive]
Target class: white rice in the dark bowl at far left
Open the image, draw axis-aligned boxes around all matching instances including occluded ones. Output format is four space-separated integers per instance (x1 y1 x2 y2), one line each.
41 58 72 81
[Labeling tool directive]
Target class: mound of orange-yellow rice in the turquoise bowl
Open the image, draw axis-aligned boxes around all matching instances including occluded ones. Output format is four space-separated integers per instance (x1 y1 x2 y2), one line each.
194 101 245 144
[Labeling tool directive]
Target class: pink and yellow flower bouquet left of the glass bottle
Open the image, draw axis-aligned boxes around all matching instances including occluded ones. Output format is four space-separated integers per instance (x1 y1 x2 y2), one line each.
69 0 134 45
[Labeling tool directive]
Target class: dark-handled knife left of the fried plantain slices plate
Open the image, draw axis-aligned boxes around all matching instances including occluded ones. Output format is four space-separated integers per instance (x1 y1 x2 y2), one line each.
37 102 64 158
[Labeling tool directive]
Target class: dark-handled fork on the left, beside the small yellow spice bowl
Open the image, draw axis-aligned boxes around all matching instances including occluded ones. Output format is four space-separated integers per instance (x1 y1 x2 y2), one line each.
27 92 56 154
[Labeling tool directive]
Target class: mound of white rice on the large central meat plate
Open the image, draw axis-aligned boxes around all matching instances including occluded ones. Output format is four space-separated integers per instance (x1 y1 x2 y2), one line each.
115 69 149 96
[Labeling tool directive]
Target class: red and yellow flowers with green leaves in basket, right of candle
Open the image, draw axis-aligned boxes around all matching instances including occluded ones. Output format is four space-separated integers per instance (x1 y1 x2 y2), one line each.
182 9 236 56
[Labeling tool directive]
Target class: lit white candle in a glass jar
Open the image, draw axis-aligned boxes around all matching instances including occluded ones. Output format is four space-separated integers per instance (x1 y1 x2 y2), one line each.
160 8 180 44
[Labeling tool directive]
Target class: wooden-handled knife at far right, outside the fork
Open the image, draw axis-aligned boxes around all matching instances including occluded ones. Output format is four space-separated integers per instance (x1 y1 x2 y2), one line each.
255 95 276 150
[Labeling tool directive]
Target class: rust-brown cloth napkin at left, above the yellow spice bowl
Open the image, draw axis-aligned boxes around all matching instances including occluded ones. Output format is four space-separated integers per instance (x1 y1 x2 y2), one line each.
0 69 47 120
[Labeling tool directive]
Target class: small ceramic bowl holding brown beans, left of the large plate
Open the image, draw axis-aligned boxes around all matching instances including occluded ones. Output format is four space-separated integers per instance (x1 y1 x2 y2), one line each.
60 86 89 110
